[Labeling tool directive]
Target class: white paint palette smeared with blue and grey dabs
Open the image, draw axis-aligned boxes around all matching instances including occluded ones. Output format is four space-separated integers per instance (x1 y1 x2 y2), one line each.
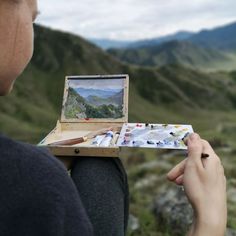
117 123 193 149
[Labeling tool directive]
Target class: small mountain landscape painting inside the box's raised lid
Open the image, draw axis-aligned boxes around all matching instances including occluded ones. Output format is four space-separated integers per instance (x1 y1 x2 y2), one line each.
64 79 124 119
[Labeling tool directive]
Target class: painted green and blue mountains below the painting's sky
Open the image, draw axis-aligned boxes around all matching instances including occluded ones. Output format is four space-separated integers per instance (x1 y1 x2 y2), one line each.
65 87 124 119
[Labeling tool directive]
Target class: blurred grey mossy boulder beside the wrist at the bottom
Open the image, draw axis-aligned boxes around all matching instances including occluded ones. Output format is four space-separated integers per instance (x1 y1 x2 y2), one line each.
154 187 193 236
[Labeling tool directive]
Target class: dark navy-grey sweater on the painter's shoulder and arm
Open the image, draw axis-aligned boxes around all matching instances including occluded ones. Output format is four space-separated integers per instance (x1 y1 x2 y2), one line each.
0 135 93 236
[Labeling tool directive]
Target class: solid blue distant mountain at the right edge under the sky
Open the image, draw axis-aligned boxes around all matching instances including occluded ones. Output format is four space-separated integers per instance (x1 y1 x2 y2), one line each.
187 22 236 52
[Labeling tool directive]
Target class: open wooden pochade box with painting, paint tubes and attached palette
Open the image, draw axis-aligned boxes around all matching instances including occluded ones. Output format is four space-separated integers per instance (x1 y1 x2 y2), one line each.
39 75 193 157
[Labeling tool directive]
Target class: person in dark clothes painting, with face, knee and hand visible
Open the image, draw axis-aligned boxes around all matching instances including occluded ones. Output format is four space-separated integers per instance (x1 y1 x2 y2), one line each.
0 0 226 236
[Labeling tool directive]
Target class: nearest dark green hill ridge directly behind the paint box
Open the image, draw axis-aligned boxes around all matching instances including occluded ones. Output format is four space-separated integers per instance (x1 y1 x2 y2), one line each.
0 26 236 142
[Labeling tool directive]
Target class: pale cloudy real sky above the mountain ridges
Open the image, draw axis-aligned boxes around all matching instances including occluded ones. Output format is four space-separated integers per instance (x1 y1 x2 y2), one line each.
36 0 236 41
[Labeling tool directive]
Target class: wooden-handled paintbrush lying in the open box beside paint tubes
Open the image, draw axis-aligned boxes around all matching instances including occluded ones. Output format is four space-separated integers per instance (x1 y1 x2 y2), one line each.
48 127 113 146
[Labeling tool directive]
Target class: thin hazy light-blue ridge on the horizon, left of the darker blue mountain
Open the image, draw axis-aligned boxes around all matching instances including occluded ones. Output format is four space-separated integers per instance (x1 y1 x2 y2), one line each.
126 31 194 48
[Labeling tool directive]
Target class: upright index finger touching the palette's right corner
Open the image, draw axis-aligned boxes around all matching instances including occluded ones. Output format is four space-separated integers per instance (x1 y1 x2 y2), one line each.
187 133 203 169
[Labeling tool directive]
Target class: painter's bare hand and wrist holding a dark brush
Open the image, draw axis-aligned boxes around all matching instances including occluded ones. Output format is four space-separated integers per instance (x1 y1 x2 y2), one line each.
167 134 227 236
